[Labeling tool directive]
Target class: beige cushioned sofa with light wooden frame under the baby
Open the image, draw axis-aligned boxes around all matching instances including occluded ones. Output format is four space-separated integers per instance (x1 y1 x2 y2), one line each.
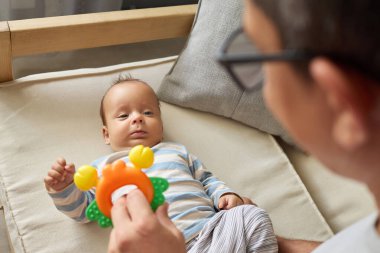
0 3 375 252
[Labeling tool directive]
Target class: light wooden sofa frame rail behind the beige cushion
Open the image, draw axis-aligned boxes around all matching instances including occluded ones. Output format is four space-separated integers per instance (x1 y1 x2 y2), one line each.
0 5 197 83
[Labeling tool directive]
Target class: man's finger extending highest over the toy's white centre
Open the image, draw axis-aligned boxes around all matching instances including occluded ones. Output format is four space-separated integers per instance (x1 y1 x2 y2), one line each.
126 189 153 220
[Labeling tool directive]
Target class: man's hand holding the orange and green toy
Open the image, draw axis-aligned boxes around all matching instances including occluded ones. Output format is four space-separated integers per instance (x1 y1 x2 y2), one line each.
108 190 185 253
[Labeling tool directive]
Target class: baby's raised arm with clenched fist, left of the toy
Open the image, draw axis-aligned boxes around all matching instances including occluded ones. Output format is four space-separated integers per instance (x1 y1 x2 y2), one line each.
44 158 95 222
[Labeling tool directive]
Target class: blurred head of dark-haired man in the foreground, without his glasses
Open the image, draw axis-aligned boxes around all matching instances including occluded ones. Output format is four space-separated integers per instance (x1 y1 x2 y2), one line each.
244 0 380 180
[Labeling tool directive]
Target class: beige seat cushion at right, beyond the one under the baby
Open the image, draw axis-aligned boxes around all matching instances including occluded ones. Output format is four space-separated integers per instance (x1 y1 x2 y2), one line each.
282 144 377 233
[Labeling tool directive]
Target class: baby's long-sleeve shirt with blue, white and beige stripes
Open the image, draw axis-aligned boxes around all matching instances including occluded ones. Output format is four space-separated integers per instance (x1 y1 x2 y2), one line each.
49 142 236 242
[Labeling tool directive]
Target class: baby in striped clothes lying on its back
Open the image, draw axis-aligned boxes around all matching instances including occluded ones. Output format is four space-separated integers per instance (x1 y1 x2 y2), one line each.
44 78 277 252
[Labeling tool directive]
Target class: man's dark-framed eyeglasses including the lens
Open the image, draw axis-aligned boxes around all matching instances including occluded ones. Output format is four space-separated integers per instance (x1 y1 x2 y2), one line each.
218 27 314 91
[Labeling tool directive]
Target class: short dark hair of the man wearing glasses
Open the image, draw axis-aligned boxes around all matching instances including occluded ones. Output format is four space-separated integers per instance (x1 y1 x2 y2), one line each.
253 0 380 81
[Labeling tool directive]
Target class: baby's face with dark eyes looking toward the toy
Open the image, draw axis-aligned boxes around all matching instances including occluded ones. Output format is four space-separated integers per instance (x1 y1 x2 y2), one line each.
103 81 163 151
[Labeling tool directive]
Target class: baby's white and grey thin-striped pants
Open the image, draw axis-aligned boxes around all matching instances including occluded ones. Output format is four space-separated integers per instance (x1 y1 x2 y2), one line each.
186 205 278 253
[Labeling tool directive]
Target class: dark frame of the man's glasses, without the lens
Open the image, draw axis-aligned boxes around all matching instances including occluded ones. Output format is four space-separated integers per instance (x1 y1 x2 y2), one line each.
217 27 315 91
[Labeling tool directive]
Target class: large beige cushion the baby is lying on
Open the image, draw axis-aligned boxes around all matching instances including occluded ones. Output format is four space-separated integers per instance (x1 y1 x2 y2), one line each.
0 58 332 253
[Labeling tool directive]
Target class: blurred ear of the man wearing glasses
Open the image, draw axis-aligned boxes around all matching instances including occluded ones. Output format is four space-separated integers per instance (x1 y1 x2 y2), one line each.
310 57 374 151
